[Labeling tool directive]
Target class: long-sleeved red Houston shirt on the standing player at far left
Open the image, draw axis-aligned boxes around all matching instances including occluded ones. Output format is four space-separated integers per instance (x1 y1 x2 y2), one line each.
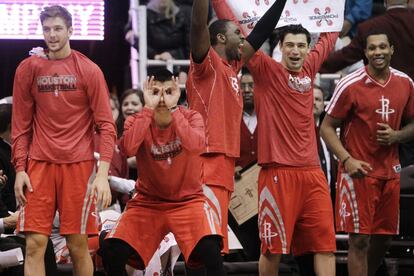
12 50 116 171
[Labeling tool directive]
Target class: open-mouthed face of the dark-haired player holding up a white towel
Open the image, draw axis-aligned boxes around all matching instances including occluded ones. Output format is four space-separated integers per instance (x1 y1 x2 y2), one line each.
280 33 309 72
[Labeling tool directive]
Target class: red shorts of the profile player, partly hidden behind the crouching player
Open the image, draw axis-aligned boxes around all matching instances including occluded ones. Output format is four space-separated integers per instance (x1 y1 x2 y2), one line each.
203 185 231 254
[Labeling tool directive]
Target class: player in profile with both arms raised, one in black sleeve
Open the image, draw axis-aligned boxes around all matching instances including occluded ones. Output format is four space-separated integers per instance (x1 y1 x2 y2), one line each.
186 0 286 260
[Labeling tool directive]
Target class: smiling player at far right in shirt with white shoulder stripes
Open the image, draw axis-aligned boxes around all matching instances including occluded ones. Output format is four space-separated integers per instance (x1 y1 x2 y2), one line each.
321 30 414 276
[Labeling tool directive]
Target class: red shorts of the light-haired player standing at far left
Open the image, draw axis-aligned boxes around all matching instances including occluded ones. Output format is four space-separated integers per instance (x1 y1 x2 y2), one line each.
17 160 98 235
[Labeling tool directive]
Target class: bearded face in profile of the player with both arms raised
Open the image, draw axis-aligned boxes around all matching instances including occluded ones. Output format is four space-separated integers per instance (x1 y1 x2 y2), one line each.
223 22 244 61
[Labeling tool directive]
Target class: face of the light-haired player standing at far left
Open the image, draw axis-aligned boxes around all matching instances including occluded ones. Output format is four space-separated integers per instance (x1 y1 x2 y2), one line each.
42 17 73 58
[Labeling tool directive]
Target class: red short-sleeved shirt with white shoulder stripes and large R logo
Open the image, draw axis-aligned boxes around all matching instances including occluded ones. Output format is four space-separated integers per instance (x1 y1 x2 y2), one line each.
327 68 414 179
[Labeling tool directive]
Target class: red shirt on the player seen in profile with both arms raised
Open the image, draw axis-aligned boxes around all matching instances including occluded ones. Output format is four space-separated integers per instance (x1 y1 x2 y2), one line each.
186 47 243 191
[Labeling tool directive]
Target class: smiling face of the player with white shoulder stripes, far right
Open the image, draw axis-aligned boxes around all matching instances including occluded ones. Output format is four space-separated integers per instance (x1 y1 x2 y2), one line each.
365 34 394 75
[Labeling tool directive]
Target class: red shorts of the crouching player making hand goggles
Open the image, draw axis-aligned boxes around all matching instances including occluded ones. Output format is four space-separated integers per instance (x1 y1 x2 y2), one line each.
107 195 220 269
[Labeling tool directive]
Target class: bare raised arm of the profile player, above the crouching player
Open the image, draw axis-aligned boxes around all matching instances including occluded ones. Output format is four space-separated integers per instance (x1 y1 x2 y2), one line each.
190 0 211 63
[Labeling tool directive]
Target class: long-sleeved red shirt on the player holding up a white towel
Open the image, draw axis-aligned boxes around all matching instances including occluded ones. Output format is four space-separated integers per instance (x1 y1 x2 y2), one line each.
248 33 338 167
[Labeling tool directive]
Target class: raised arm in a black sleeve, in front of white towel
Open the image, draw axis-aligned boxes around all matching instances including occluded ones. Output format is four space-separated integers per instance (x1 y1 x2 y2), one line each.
243 0 286 63
